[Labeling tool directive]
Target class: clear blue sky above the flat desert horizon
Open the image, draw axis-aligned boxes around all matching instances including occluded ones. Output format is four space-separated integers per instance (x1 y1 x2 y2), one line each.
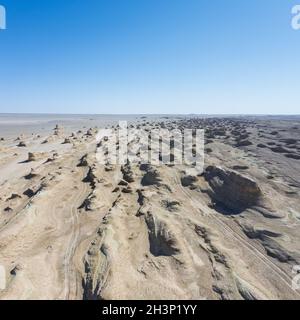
0 0 300 114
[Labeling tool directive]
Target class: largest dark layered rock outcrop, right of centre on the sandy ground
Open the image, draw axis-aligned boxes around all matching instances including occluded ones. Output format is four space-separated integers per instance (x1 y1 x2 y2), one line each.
204 166 262 212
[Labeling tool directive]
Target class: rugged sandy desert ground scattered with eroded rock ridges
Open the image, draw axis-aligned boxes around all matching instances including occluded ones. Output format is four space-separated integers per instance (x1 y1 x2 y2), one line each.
0 116 300 300
